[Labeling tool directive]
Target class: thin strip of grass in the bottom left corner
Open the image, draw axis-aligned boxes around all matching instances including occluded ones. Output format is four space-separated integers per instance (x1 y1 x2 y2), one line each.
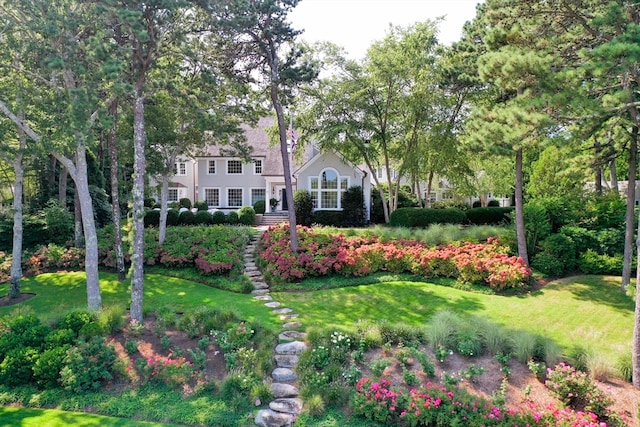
0 407 180 427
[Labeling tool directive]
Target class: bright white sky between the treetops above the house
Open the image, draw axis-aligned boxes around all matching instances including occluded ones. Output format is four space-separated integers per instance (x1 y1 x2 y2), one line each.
289 0 482 59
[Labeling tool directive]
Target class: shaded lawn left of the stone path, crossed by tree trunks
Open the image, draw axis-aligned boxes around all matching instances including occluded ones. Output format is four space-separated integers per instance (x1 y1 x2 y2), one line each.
0 272 278 326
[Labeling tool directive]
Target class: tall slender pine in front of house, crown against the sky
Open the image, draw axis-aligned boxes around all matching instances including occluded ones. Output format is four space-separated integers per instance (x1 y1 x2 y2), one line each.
198 0 316 252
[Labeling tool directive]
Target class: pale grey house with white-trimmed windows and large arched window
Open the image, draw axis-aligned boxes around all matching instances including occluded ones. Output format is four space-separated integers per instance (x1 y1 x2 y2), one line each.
154 118 371 220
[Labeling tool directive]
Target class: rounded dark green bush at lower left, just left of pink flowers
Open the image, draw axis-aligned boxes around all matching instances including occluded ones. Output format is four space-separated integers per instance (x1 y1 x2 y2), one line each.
60 337 117 393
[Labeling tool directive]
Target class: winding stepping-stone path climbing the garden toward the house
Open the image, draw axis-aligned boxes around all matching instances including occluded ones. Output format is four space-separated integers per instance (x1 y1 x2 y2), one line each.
244 227 307 427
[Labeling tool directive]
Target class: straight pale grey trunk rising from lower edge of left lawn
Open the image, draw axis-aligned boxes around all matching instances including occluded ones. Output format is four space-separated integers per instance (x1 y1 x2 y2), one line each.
130 85 146 322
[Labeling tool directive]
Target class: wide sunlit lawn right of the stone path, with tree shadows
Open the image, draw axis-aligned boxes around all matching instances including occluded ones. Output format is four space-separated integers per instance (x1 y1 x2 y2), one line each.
274 276 634 364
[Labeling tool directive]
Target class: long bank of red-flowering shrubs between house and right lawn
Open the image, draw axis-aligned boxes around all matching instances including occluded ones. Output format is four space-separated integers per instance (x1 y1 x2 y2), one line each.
259 225 531 291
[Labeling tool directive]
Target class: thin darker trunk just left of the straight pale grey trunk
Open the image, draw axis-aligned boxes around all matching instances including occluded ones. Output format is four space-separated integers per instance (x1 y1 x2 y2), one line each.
107 101 126 282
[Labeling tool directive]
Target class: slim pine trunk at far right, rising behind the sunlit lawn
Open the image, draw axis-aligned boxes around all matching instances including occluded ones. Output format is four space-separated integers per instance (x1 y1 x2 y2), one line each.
620 126 638 292
